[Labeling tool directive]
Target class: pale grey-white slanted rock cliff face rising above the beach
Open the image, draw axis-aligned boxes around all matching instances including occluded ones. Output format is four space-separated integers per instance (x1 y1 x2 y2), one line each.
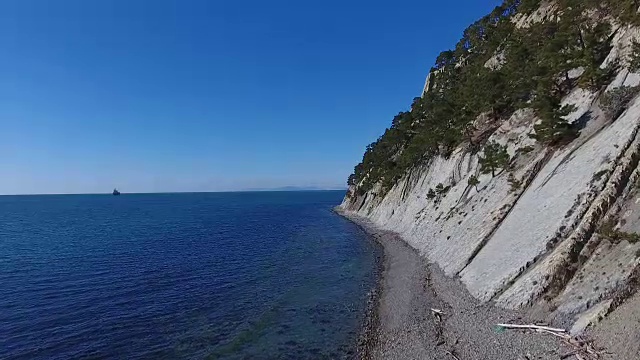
340 3 640 332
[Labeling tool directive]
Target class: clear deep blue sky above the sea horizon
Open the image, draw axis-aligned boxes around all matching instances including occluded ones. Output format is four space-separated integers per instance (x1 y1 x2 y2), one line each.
0 0 500 194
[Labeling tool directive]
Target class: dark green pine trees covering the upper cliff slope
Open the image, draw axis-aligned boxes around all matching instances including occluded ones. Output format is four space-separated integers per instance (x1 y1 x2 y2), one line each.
348 0 640 195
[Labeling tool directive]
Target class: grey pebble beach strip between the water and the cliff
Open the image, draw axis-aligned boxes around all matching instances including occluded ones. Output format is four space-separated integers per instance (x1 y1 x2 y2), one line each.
335 208 568 360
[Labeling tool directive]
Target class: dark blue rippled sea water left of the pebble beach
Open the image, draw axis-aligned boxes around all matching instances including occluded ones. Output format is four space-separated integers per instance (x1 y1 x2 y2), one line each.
0 192 378 359
